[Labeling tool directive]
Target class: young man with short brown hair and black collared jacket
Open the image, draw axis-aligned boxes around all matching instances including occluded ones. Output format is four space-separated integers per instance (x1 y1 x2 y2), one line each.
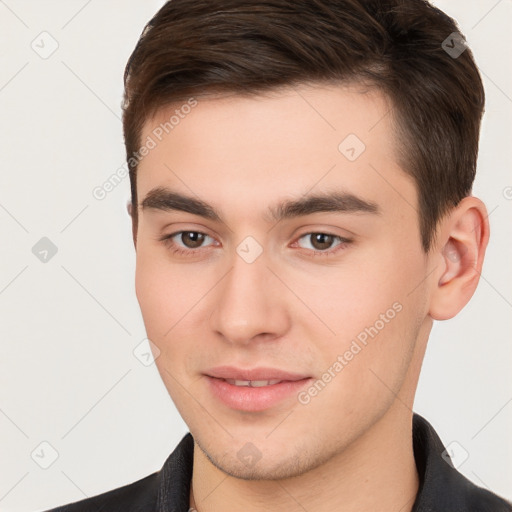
46 0 512 512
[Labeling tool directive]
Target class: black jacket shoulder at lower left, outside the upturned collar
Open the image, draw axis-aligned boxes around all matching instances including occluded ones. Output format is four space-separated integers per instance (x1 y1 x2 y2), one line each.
40 471 160 512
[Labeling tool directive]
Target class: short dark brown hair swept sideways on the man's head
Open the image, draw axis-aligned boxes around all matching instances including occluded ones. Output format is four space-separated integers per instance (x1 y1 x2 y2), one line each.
123 0 484 252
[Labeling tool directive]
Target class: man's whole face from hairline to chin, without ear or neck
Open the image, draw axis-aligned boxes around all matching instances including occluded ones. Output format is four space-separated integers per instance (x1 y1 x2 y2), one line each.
136 86 431 479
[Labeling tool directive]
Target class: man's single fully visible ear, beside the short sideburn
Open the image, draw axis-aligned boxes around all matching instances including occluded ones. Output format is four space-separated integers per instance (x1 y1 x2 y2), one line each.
429 196 490 320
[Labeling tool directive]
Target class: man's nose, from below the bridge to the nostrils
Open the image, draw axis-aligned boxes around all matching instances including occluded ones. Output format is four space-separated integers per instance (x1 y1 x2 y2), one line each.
209 255 290 345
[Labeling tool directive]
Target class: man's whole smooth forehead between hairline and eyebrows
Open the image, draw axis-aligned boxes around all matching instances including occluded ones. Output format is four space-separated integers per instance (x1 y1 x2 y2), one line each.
137 85 415 222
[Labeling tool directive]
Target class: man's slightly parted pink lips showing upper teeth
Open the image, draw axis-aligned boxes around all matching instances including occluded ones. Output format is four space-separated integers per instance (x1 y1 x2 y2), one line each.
204 366 313 412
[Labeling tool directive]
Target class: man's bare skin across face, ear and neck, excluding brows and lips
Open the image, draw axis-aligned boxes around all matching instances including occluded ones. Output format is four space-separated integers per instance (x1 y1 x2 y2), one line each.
133 85 489 512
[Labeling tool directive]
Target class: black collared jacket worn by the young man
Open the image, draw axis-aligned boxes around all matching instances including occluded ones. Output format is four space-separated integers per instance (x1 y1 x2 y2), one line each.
47 414 512 512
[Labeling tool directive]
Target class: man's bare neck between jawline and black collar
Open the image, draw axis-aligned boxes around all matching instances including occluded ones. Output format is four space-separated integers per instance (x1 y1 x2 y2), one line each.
190 400 419 512
